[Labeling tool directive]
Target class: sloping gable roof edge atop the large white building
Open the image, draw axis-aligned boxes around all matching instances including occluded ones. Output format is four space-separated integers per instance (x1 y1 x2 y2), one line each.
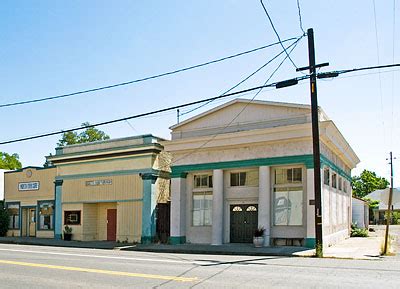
169 98 329 130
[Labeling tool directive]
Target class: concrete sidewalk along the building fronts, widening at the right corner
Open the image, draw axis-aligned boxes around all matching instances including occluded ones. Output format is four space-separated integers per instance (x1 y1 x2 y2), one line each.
0 233 383 260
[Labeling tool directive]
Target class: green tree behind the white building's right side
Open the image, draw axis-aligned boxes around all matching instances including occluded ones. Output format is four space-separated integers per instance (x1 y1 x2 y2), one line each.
351 170 389 198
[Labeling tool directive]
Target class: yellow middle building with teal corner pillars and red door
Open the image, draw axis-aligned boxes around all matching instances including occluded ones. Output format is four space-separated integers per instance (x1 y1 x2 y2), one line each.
47 135 169 243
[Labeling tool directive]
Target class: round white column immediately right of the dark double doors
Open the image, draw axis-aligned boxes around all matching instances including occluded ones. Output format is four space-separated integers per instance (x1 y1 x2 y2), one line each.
258 166 273 246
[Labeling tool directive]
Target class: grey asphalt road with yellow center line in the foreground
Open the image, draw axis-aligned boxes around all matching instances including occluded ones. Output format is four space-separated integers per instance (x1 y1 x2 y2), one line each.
0 244 400 289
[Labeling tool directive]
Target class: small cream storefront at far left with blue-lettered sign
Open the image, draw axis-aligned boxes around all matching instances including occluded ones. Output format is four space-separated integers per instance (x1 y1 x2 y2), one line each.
4 167 56 238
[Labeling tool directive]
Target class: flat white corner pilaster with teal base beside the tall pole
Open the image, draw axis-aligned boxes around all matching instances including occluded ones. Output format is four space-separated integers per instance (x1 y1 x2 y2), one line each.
304 168 316 248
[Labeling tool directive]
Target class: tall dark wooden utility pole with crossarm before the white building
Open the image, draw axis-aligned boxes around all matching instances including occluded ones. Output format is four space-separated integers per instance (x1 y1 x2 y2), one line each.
296 28 329 257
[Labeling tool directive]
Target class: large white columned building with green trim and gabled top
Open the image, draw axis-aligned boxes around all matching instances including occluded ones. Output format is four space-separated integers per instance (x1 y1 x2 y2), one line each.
162 99 359 247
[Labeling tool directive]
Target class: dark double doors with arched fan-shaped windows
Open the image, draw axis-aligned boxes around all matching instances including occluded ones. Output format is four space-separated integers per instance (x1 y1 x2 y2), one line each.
230 204 258 243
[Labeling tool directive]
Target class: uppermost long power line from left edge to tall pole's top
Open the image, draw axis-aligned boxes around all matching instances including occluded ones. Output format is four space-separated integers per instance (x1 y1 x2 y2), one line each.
0 37 298 108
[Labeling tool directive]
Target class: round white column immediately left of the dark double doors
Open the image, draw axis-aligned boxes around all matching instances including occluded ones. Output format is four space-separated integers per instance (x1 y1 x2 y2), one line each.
211 170 224 245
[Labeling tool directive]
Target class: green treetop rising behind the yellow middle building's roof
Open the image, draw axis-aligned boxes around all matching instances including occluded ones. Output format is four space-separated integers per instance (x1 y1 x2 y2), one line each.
57 122 110 146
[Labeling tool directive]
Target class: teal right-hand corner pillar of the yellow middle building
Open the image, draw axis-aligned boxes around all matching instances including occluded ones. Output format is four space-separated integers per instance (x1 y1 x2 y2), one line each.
141 174 157 244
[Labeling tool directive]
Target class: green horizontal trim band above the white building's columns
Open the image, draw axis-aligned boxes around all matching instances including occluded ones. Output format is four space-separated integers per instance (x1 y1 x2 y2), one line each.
171 154 351 180
